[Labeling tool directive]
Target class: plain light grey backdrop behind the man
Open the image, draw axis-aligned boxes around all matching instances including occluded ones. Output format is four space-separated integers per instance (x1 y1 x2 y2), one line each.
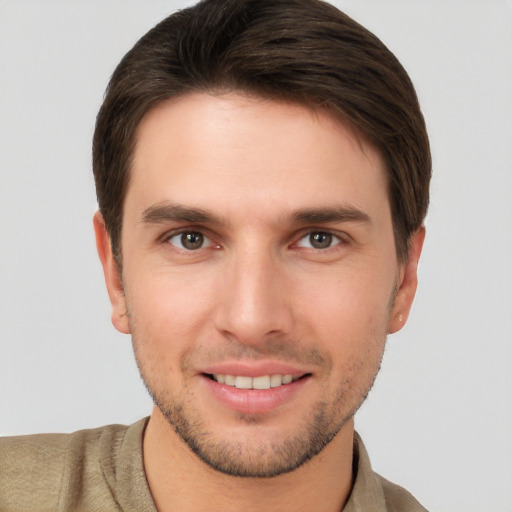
0 0 512 512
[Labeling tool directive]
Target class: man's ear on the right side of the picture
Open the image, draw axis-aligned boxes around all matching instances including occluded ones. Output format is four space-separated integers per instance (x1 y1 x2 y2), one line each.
388 226 425 334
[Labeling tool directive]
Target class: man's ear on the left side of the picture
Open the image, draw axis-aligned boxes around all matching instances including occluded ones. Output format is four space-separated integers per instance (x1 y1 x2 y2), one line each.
93 212 130 334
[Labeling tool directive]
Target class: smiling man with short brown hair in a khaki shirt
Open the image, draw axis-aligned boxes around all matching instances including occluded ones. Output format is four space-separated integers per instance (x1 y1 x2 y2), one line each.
0 0 431 512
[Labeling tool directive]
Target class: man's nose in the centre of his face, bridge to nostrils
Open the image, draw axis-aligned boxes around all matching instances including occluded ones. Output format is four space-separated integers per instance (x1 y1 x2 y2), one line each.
215 245 293 345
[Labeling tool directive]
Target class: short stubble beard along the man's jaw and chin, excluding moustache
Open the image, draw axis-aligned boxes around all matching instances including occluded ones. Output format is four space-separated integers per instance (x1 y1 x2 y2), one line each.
133 334 384 478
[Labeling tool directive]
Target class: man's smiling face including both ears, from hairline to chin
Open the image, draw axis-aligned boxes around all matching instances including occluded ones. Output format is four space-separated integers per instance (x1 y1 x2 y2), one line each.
96 94 422 476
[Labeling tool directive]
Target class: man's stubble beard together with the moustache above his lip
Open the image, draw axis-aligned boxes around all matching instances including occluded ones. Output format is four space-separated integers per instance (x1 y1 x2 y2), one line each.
126 278 397 478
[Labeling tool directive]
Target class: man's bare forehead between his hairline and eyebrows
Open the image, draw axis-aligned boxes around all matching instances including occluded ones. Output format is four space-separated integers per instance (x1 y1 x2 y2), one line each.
126 93 387 224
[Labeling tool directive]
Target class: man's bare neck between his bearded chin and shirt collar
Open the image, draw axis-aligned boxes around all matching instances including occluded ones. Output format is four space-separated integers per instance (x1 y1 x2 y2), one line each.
144 408 354 512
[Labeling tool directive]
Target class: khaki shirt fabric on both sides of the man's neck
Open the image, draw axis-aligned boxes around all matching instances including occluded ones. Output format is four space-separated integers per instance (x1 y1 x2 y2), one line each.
0 418 426 512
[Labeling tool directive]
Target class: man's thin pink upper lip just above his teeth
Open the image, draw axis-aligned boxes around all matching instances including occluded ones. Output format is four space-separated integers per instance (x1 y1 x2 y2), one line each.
200 361 311 377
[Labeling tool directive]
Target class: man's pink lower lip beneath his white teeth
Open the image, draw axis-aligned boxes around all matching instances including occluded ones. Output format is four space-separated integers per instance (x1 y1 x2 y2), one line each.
203 376 309 414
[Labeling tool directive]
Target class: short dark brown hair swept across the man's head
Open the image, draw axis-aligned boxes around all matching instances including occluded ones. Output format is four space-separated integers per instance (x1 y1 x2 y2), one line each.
93 0 431 263
